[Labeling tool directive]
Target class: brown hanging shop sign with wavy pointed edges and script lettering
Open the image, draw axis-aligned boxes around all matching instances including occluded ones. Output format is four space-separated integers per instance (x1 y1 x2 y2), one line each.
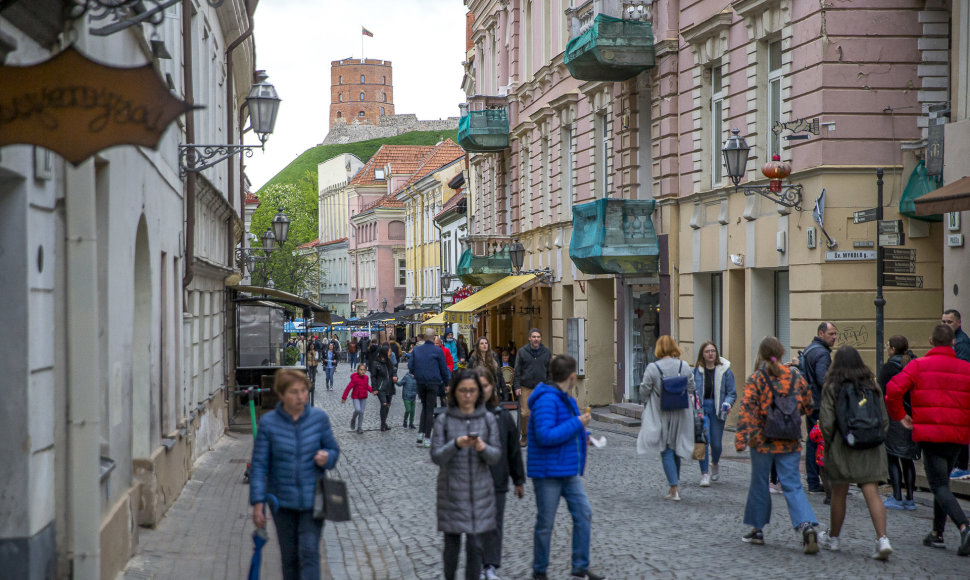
0 47 194 165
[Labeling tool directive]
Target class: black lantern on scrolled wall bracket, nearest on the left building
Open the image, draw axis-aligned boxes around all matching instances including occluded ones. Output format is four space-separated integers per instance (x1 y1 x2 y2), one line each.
179 70 280 174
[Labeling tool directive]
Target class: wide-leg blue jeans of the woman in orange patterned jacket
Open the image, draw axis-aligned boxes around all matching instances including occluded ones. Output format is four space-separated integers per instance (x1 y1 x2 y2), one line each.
744 449 818 530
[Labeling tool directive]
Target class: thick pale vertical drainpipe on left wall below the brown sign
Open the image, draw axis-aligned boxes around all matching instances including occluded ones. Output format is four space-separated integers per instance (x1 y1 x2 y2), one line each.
64 160 102 580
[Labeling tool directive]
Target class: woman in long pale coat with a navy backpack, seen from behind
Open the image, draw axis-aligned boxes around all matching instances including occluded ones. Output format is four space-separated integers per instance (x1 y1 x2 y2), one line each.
637 335 694 501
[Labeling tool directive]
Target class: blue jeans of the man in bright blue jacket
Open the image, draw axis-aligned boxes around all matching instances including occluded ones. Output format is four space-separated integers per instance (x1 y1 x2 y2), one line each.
532 475 593 573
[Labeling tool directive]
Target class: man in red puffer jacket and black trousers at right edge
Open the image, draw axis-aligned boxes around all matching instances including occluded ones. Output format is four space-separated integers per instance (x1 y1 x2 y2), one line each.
886 324 970 556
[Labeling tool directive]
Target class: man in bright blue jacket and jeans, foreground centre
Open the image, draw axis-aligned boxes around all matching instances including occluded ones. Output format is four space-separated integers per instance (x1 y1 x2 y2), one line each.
527 355 603 580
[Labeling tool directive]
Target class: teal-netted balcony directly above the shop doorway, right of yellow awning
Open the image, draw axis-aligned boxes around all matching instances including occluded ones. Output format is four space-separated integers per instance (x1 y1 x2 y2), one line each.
569 198 660 275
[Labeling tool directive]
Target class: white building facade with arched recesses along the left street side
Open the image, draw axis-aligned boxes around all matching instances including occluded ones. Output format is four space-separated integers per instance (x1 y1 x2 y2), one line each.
0 0 256 579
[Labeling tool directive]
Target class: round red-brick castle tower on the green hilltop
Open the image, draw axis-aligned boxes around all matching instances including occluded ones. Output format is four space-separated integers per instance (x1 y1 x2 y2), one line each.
330 58 394 128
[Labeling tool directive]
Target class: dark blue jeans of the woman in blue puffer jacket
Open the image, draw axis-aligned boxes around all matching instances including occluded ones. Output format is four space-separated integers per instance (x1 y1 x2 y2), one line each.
273 508 323 580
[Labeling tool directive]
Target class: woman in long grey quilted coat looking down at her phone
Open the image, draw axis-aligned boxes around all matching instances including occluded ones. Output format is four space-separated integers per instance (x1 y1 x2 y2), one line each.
431 369 502 580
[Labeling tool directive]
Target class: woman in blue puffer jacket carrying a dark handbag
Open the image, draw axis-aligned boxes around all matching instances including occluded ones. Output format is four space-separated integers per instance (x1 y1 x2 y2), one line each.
249 369 340 580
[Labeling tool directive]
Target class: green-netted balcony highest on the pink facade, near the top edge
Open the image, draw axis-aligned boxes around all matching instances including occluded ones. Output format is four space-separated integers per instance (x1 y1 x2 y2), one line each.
563 14 656 81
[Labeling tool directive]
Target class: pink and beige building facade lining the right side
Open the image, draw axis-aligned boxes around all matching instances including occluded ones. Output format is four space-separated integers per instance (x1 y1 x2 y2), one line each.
463 0 950 402
